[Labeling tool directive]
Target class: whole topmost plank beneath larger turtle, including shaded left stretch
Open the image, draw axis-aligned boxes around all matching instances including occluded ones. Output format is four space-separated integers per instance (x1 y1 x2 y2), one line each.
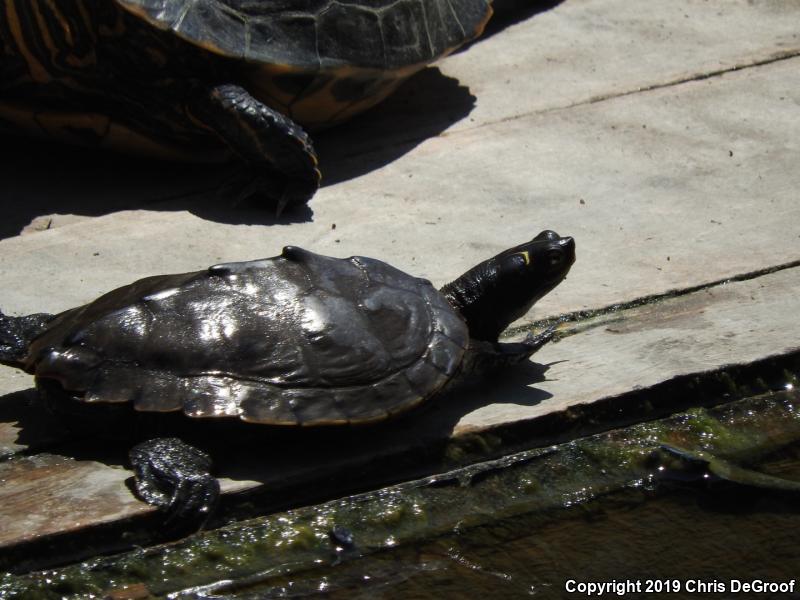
0 0 800 236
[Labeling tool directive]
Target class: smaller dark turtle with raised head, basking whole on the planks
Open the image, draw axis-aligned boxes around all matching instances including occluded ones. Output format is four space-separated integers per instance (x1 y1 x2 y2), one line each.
0 231 575 512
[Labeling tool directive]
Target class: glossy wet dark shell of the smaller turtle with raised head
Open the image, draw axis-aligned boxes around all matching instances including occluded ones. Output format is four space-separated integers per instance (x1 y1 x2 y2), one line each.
24 247 469 425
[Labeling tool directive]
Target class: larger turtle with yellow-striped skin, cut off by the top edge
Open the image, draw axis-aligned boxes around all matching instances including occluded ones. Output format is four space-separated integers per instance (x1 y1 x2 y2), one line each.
0 0 491 208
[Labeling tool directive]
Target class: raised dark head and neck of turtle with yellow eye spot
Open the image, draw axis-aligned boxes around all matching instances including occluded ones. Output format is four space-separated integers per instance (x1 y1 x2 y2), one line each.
441 231 575 342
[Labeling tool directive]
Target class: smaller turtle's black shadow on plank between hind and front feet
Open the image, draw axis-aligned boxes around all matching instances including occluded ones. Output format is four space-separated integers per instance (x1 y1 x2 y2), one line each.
201 363 552 502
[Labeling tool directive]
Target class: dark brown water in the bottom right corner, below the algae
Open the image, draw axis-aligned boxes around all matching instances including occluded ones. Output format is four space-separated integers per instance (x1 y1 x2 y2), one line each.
223 453 800 600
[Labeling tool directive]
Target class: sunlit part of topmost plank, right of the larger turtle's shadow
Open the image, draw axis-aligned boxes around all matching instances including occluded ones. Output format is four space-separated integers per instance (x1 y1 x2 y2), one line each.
450 0 800 130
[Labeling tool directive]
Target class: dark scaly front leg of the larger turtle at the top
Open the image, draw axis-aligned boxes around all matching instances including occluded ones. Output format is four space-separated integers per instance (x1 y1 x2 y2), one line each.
189 85 320 214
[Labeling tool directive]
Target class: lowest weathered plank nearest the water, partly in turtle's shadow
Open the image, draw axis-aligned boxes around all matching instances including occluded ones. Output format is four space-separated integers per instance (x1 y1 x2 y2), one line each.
0 268 800 549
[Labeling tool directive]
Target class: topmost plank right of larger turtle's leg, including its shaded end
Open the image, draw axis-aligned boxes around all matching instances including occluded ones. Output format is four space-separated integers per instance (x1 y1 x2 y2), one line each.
323 0 800 157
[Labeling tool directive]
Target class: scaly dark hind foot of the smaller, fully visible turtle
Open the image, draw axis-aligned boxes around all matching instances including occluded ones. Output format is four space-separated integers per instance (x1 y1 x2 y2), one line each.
129 438 219 528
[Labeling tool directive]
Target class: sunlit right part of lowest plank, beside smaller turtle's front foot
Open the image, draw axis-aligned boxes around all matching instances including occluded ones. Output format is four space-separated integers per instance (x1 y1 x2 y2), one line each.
454 268 800 435
